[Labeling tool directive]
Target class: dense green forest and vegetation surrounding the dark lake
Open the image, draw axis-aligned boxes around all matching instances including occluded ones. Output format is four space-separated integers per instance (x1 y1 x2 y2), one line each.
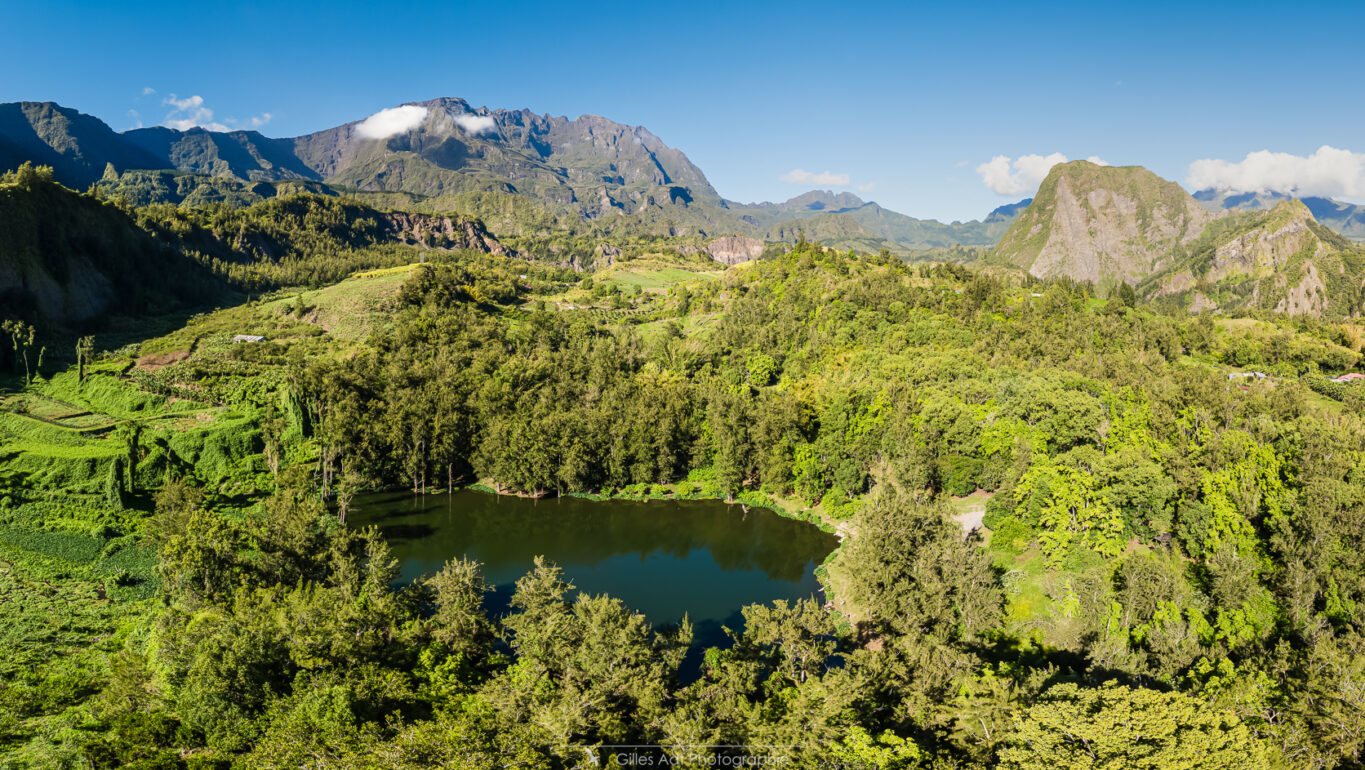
0 176 1365 769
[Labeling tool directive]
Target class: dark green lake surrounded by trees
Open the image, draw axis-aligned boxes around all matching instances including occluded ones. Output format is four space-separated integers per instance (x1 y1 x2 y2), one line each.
347 491 838 650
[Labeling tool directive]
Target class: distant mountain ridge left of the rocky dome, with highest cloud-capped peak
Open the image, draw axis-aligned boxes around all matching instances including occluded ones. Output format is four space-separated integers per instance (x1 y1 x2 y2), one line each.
0 98 1017 253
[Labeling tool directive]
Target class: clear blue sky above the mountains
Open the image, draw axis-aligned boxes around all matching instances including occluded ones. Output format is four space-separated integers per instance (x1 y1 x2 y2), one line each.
0 0 1365 220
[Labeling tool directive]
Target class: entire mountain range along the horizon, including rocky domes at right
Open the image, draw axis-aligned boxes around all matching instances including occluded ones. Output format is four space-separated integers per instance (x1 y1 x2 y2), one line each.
0 98 1365 314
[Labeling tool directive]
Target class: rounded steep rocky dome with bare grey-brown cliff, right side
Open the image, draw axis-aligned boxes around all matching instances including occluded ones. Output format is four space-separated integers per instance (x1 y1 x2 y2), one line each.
994 161 1215 284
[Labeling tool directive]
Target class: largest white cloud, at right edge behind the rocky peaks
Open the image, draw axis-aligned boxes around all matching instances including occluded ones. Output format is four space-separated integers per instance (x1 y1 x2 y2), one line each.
1185 145 1365 198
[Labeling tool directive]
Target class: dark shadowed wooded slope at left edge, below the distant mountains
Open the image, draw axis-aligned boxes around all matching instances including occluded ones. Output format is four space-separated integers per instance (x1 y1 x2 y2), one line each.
0 165 511 328
